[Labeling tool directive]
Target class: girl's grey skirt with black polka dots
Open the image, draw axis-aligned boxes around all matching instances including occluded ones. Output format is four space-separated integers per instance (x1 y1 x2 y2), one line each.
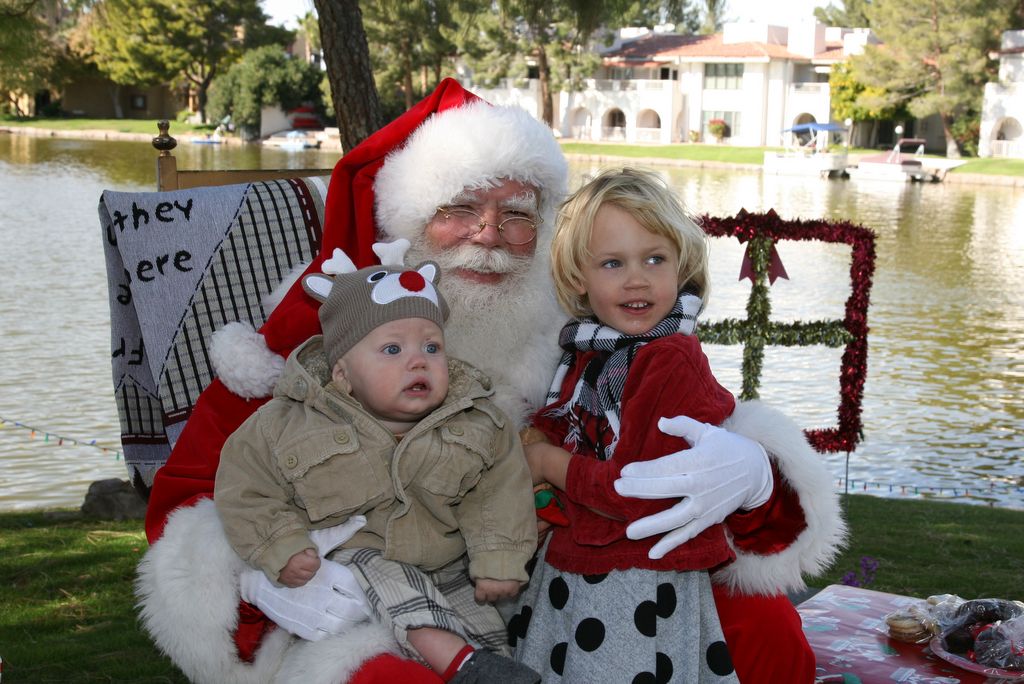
509 560 738 684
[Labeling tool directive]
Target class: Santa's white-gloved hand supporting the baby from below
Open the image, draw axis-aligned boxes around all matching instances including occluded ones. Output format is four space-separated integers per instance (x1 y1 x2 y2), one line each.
240 515 371 641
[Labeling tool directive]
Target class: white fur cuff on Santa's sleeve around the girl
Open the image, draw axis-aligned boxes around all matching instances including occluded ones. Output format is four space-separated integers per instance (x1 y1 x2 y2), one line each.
715 401 847 594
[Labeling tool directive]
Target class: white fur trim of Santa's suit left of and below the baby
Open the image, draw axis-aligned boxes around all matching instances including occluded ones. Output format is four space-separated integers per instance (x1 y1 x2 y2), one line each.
135 499 397 684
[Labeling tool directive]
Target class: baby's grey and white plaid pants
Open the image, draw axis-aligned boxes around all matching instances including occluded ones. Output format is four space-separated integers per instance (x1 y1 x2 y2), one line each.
331 549 512 662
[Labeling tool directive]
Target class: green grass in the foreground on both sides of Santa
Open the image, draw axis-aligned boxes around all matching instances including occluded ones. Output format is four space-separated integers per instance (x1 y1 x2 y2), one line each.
0 496 1024 682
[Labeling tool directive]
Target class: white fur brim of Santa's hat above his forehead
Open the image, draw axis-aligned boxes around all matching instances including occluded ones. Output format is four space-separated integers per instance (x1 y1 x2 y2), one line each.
374 101 568 242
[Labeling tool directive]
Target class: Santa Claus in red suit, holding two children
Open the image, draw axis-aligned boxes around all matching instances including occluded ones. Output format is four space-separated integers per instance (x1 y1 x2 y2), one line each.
137 80 845 683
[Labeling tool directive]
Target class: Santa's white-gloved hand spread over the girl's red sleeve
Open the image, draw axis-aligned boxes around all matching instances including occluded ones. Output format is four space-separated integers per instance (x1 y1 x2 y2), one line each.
614 416 774 559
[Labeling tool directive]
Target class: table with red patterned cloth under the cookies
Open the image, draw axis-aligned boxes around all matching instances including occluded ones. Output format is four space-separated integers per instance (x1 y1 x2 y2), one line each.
797 585 1007 684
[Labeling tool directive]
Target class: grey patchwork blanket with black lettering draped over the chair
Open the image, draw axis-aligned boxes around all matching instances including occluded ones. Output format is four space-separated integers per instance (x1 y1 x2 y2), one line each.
99 178 327 488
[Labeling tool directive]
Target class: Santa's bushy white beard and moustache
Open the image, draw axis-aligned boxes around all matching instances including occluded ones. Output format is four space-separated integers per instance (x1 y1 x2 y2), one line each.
406 237 565 423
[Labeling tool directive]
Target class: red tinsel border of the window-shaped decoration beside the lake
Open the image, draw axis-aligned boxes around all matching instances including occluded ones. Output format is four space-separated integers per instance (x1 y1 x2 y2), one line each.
701 209 874 453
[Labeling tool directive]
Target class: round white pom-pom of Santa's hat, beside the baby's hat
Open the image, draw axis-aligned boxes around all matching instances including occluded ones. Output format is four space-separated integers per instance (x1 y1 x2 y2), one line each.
210 322 285 399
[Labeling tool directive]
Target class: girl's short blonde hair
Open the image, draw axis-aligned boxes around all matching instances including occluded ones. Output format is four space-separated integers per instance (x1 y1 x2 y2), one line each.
551 168 711 316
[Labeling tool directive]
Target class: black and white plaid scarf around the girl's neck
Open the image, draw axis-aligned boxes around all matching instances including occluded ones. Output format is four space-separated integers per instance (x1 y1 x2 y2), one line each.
545 292 701 460
